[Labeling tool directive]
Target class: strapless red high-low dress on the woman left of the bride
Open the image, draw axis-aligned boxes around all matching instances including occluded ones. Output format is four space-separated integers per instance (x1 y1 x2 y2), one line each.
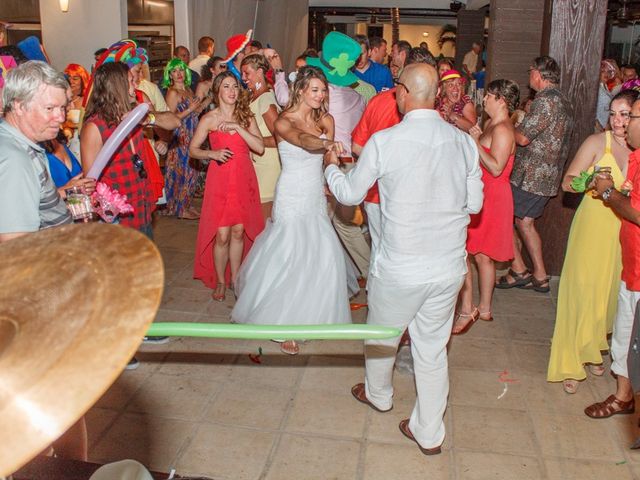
193 130 264 288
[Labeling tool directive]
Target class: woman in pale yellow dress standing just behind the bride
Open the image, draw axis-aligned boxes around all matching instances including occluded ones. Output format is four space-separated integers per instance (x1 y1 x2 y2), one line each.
240 53 281 220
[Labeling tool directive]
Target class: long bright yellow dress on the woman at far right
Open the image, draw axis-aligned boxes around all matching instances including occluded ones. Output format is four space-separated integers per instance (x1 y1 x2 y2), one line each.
547 132 624 382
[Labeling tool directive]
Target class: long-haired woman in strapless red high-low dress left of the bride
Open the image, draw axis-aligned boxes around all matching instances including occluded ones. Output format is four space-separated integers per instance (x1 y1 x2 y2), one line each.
189 72 264 302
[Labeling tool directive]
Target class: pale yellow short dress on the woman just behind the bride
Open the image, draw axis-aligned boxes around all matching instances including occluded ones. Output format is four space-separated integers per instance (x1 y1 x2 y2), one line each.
249 91 281 203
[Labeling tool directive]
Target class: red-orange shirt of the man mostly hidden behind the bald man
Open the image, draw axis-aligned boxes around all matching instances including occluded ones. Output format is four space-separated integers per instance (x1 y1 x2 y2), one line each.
351 88 401 203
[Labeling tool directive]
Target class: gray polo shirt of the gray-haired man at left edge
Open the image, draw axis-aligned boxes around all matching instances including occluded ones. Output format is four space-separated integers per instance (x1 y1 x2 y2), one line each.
0 120 72 233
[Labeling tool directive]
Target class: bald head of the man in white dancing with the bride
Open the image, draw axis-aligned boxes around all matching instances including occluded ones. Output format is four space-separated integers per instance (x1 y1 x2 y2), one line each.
396 63 438 113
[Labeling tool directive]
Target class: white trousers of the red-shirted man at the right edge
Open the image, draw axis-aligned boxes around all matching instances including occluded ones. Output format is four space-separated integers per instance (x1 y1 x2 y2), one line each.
611 282 640 378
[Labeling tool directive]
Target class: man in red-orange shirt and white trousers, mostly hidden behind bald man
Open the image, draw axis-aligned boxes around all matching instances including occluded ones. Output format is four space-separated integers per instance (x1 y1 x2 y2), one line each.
351 48 436 253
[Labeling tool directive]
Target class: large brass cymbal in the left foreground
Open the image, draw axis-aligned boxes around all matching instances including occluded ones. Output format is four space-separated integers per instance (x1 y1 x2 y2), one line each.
0 223 164 477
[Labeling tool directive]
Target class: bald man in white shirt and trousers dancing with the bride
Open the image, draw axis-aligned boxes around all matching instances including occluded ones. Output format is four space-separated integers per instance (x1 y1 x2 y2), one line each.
325 64 483 455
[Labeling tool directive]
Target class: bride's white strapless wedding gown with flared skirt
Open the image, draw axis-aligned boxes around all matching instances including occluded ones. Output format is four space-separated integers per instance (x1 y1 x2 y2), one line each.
231 141 358 325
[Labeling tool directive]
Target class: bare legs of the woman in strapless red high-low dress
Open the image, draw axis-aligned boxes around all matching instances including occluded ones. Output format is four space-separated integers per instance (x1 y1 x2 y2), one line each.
213 224 244 301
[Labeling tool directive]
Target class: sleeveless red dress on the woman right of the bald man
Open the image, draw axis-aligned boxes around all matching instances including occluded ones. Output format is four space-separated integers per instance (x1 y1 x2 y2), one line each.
467 147 514 262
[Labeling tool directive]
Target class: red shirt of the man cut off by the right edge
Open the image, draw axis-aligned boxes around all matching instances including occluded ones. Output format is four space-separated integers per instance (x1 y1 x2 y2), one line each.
620 149 640 292
